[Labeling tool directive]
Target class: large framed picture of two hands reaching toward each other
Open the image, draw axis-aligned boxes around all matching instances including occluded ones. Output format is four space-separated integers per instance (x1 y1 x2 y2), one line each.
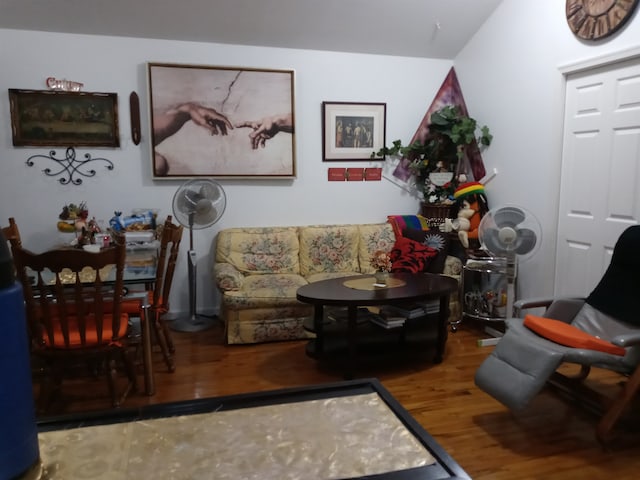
147 63 296 179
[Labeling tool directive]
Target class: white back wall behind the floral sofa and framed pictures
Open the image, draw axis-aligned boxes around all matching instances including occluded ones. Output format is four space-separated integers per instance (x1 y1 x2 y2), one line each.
0 29 450 311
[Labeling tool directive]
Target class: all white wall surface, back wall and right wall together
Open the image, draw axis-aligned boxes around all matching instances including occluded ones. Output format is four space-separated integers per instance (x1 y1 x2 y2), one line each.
6 0 640 311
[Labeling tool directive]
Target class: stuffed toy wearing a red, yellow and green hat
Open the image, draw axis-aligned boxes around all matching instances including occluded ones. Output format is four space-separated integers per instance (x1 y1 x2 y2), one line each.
440 182 489 248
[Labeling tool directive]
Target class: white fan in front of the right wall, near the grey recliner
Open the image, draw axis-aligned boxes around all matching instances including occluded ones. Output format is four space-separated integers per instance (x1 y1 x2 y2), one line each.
478 205 542 317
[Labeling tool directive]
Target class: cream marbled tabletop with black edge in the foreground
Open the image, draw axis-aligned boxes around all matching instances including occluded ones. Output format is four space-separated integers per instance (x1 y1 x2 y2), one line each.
38 382 465 480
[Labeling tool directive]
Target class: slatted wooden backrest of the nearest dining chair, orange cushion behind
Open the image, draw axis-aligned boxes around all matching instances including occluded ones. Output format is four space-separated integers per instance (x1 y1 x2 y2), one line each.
12 245 127 351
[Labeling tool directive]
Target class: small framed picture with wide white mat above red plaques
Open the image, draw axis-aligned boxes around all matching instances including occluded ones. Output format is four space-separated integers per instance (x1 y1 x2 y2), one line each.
322 102 387 162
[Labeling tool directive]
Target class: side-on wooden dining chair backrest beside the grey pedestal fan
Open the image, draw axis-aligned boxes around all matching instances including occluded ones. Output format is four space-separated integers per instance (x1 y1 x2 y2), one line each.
151 215 184 312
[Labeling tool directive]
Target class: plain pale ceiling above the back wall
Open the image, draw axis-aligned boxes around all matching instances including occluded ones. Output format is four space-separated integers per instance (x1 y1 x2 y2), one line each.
0 0 502 59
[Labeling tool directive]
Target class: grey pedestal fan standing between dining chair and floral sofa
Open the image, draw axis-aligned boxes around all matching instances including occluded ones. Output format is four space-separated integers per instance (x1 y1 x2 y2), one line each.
170 179 227 332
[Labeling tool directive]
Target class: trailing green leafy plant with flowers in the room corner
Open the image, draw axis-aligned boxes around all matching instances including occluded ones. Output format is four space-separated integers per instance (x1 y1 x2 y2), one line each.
371 105 493 204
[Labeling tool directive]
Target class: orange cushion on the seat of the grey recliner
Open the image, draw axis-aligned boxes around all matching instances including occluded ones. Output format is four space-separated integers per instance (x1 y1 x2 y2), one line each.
524 314 626 356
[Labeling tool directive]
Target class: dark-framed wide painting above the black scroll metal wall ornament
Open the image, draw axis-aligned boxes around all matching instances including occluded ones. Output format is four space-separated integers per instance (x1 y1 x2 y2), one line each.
9 88 120 147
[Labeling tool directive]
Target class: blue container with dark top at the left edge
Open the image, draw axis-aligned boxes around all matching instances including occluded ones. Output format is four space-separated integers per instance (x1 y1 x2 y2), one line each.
0 232 40 479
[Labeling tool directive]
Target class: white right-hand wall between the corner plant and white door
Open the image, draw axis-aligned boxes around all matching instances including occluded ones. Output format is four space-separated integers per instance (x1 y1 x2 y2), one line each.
455 0 640 297
